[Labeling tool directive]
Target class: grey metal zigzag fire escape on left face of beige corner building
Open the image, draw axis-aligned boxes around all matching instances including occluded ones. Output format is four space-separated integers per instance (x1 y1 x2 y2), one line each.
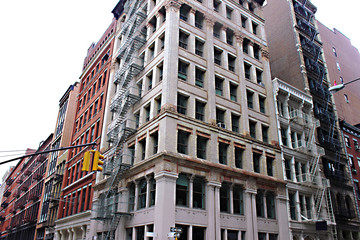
96 0 146 239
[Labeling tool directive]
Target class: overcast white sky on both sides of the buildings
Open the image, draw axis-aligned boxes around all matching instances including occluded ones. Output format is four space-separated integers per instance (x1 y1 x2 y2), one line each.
0 0 360 180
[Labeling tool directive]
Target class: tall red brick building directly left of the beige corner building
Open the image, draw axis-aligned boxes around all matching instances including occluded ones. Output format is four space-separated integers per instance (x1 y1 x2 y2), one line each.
55 21 116 239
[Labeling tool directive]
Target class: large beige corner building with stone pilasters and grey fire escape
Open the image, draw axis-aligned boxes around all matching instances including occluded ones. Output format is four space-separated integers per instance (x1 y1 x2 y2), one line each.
90 0 289 240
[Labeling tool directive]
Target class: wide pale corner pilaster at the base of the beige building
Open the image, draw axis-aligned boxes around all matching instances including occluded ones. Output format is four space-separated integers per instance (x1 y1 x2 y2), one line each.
154 171 178 239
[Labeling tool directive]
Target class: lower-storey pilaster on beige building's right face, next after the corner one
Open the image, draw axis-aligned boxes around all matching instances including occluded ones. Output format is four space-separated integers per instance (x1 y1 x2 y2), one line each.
206 181 221 240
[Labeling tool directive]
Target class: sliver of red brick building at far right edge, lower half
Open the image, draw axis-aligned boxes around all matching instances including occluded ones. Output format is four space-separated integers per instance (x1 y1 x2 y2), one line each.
340 121 360 218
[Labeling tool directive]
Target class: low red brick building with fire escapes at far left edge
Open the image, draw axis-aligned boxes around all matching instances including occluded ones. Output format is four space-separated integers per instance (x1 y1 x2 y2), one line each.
0 134 53 240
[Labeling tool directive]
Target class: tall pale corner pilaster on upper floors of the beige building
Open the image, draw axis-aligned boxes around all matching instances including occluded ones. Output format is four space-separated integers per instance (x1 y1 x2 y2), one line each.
161 0 181 109
